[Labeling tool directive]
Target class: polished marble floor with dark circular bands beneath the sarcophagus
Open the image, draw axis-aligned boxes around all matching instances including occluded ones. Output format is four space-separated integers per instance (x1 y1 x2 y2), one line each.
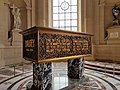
0 61 120 90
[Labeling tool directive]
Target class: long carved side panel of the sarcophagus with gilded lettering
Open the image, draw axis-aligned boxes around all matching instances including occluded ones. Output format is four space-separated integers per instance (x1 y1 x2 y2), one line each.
39 33 91 59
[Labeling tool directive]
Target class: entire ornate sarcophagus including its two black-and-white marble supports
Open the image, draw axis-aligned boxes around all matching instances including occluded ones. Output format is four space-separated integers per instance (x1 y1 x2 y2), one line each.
20 26 92 90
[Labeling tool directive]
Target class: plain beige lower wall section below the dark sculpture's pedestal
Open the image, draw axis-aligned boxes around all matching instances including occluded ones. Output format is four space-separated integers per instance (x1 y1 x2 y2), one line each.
94 45 120 61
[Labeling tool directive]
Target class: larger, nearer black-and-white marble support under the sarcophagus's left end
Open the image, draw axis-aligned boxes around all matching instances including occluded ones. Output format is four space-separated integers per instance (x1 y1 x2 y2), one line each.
32 62 52 90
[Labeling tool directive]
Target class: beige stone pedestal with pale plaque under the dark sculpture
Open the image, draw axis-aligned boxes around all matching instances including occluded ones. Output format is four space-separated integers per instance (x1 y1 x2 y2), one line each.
107 26 120 44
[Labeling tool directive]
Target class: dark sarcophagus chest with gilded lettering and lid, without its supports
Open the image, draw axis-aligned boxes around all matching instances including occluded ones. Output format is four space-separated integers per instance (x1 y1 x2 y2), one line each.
20 26 92 62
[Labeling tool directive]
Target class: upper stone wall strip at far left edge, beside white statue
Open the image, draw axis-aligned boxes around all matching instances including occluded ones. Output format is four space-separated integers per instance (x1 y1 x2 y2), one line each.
0 0 9 46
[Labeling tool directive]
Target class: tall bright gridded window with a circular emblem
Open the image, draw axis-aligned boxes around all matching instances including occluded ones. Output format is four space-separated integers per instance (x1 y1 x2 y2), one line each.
52 0 78 31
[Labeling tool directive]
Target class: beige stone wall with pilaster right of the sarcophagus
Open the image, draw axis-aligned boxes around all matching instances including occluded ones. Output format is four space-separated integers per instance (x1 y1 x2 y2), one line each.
89 0 120 61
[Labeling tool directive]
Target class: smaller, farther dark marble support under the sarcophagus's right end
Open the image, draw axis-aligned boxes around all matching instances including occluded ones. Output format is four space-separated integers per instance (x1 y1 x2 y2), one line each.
68 58 84 79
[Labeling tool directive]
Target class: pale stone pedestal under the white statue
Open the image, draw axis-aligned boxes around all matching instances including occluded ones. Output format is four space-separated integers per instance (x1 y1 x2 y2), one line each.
12 29 22 46
